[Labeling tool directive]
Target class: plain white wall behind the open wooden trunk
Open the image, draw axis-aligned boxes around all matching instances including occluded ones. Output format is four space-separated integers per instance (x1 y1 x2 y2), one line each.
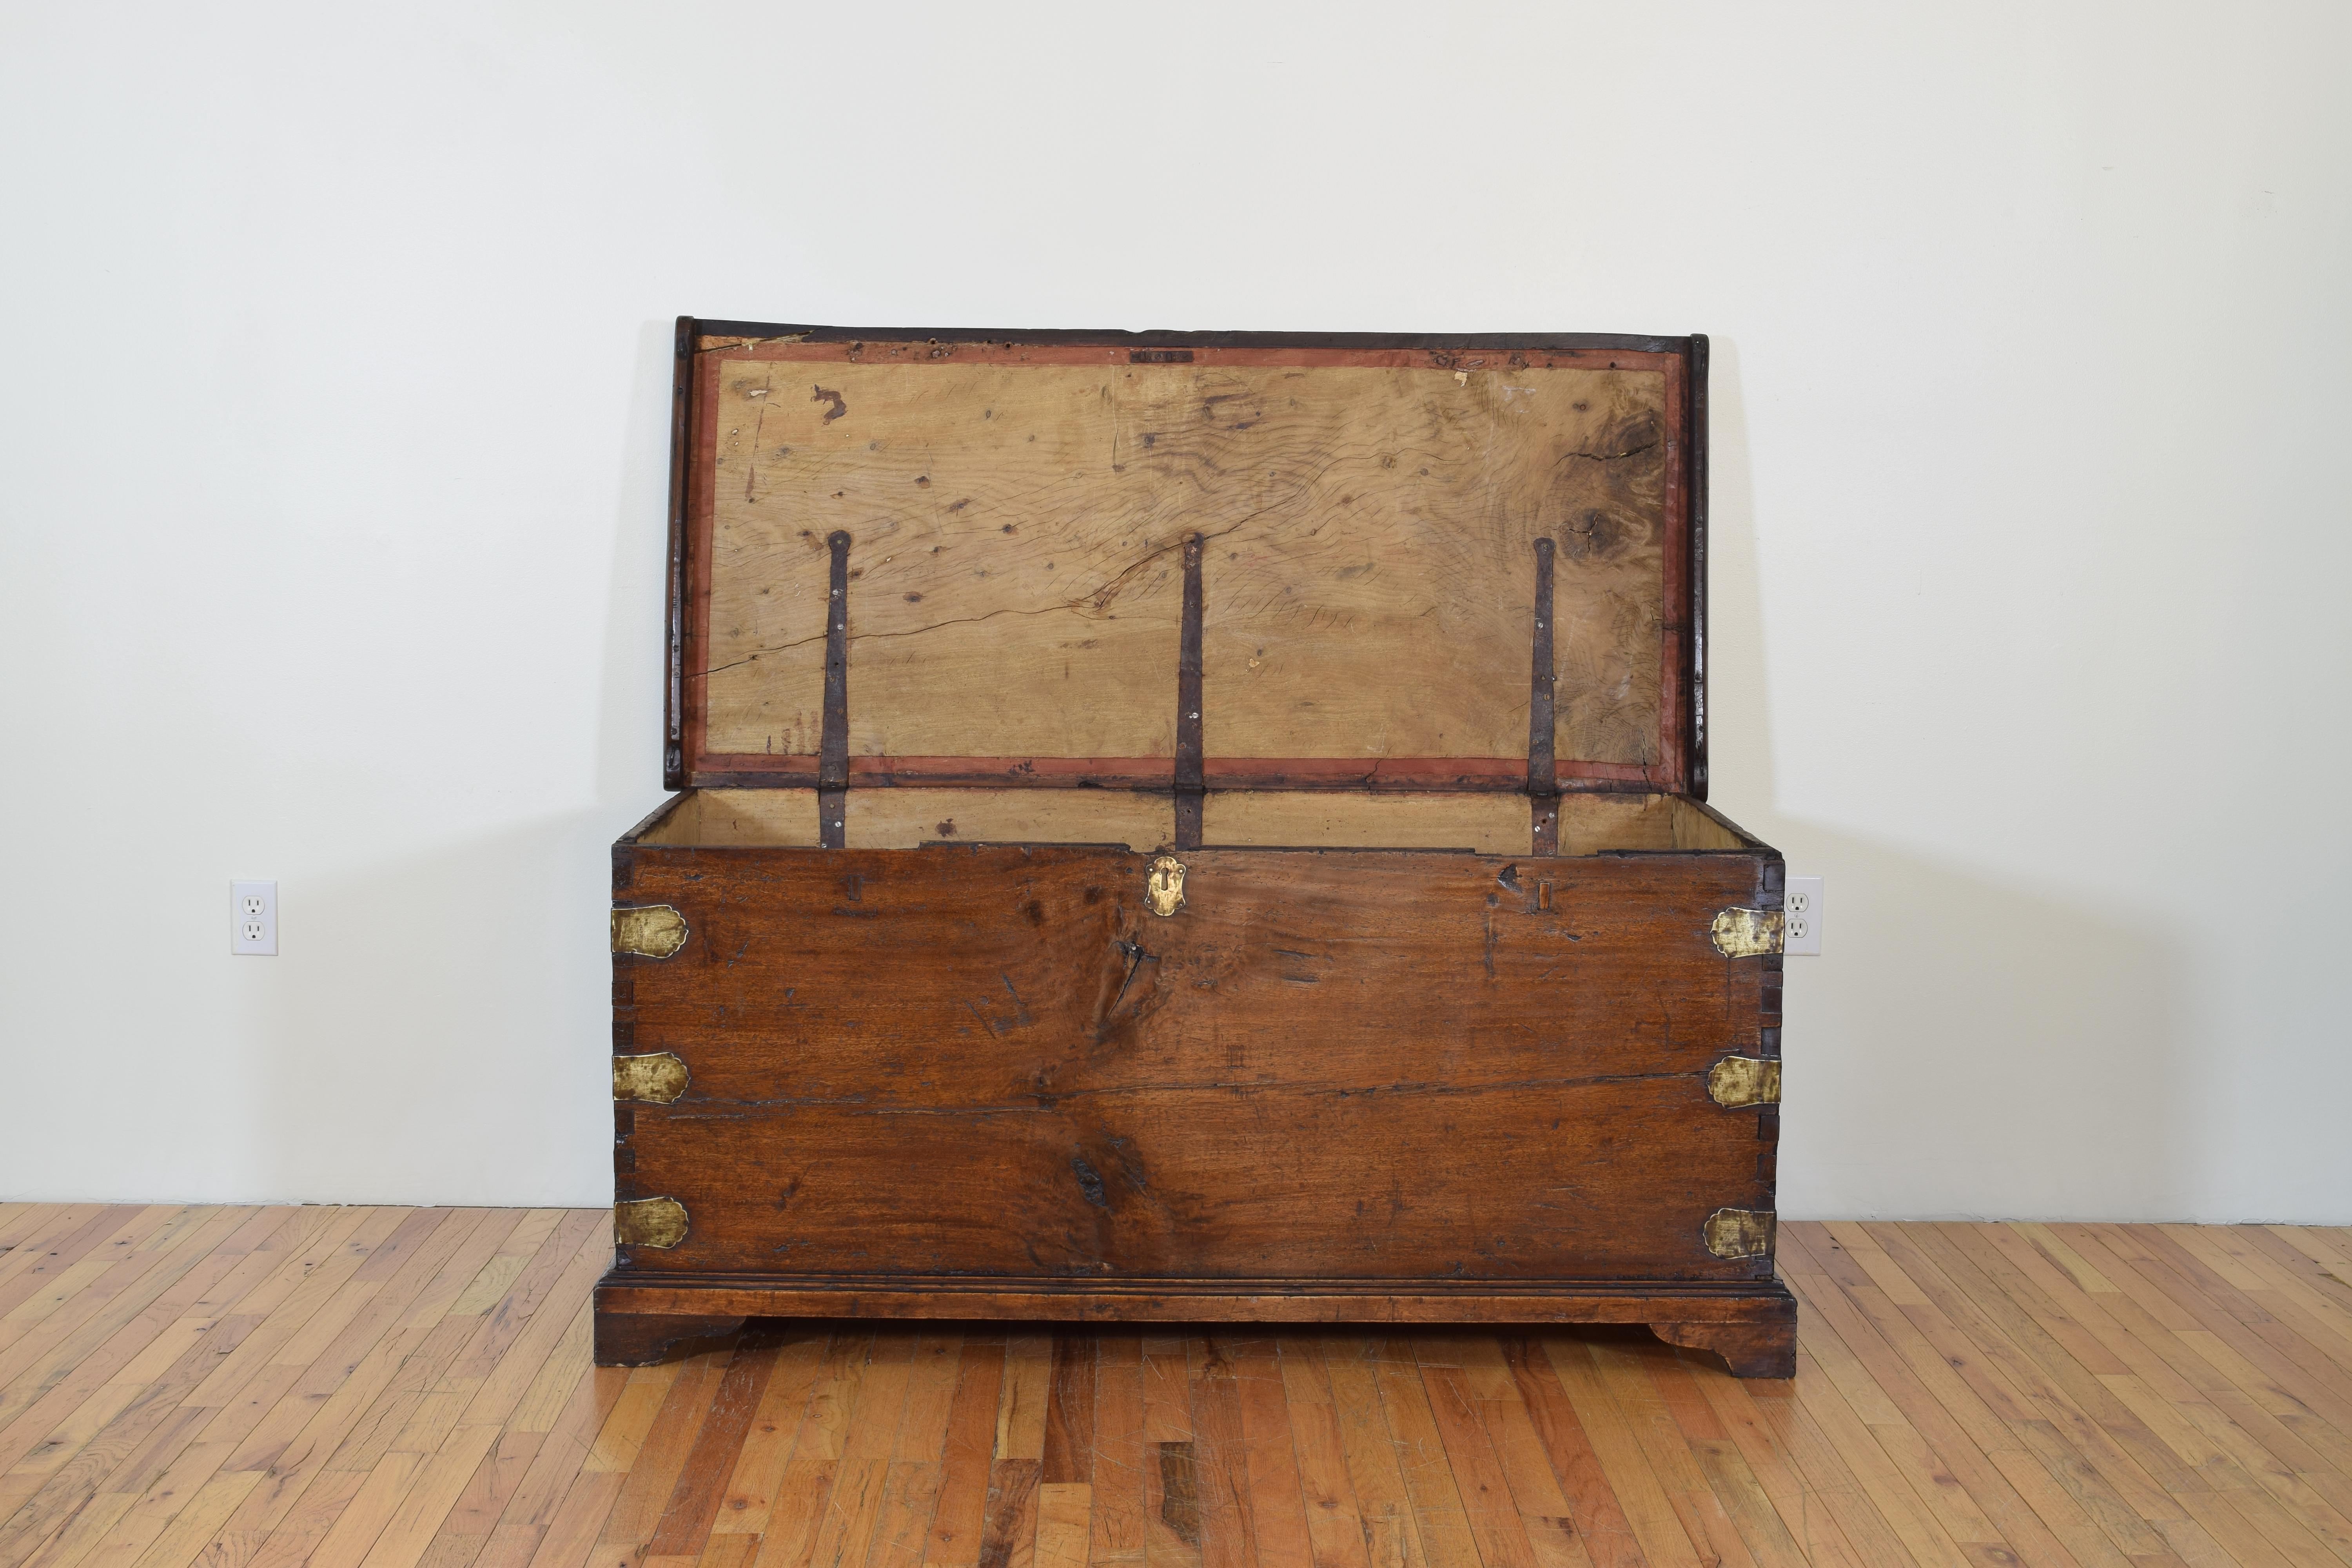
0 0 2352 1222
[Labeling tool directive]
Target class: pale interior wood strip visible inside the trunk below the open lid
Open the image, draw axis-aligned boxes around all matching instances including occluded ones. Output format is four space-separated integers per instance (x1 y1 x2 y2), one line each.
640 788 1752 856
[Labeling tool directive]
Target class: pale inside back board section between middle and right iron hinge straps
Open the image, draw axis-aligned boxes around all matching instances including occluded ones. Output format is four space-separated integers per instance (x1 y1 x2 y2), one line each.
1200 790 1534 856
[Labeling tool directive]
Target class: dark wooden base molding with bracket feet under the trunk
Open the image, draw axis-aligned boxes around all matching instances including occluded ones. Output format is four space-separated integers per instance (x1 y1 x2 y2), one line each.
595 1267 1797 1377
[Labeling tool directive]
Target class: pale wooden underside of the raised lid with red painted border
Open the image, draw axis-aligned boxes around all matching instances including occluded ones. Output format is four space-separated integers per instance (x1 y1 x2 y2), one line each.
689 346 1677 766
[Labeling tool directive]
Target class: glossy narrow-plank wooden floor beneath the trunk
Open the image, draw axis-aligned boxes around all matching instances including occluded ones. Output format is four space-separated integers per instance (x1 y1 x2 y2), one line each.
0 1203 2352 1568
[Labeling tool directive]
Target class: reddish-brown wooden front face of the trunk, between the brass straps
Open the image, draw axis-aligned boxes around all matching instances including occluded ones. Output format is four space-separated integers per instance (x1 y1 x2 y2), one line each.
621 846 1769 1309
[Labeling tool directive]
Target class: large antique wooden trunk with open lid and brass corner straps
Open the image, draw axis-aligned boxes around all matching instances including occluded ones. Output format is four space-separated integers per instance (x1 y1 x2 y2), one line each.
597 320 1795 1375
